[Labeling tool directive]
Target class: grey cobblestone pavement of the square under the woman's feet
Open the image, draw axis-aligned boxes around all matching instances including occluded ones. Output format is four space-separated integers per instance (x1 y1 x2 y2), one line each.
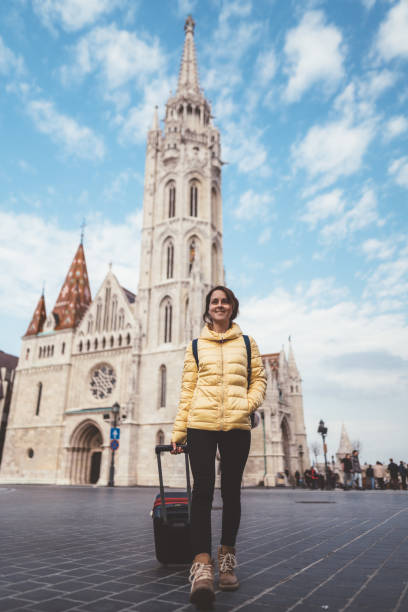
0 486 408 612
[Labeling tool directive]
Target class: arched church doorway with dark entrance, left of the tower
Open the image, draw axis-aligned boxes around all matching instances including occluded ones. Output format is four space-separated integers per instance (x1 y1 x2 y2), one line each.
69 420 103 484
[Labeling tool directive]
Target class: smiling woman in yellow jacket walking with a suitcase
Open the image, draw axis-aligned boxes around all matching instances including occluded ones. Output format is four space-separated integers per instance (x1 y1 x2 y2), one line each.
172 286 266 607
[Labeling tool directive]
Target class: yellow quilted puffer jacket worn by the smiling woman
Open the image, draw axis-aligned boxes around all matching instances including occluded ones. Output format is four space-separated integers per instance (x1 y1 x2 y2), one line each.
172 323 266 443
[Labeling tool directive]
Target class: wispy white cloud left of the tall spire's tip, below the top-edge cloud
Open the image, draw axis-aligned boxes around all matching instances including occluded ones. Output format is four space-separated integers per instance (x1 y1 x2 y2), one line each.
62 25 166 91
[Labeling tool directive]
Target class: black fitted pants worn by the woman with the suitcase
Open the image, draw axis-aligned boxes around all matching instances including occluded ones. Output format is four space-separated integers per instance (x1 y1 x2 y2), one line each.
187 429 251 555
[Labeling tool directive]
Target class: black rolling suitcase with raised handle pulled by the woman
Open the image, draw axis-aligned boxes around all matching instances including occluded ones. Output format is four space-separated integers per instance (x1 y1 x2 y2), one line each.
152 444 192 564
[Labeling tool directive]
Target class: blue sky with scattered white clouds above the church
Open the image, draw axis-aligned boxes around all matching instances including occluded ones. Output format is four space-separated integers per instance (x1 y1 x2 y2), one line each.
0 0 408 462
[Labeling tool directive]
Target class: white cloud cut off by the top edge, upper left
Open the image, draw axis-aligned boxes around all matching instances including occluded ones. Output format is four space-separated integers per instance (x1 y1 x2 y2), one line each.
33 0 123 31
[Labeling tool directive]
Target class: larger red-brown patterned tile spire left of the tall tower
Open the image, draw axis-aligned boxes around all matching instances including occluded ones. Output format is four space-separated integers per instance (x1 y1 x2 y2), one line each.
52 242 91 330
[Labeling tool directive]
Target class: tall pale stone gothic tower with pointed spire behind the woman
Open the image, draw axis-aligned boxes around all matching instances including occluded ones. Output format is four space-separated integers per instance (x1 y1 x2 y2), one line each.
135 17 224 483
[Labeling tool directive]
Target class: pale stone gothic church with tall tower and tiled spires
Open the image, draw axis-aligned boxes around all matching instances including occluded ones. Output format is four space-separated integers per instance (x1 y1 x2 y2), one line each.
0 17 310 486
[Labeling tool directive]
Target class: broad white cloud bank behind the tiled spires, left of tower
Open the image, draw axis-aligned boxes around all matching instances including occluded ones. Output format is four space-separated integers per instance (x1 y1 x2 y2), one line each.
0 211 142 320
